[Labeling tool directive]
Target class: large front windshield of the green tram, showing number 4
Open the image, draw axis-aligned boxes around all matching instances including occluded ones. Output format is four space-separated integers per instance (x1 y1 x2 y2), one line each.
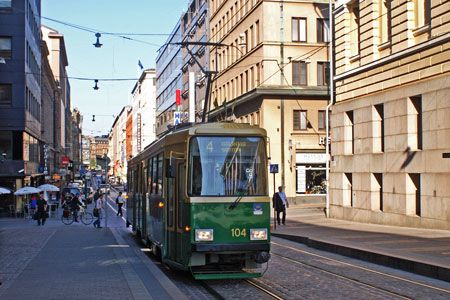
188 137 267 196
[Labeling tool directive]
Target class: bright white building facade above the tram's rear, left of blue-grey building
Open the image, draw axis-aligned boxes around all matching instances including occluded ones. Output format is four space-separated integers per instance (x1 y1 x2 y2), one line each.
131 69 156 156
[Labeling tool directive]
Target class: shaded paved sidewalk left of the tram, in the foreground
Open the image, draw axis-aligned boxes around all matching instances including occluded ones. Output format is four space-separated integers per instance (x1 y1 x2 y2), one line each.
0 207 186 300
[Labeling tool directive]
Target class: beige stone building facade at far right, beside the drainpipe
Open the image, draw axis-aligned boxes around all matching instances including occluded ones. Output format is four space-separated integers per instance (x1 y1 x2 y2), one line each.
330 0 450 230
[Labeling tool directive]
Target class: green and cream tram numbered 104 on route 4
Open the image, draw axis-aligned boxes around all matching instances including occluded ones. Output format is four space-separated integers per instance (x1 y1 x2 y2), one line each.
127 123 270 279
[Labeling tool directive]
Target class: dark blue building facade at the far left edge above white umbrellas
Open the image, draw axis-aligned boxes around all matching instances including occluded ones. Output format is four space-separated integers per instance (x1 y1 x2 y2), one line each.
0 0 44 211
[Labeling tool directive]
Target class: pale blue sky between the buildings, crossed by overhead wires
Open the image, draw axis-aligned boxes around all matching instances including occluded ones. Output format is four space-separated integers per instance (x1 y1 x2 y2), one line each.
41 0 188 135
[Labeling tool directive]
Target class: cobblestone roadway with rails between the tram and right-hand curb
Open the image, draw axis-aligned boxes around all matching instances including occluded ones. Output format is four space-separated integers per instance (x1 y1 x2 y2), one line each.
253 238 450 299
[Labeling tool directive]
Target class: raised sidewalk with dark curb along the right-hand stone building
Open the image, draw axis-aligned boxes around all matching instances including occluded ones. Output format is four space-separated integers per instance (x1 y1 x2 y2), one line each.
272 207 450 282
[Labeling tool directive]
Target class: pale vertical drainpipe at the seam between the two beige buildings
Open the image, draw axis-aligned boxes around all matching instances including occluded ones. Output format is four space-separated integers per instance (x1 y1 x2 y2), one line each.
325 0 334 218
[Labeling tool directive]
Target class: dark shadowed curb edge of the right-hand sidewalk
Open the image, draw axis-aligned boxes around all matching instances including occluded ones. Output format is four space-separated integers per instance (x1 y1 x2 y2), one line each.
271 233 450 282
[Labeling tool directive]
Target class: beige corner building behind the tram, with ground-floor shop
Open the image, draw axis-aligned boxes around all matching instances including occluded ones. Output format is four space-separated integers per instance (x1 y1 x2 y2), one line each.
208 0 329 204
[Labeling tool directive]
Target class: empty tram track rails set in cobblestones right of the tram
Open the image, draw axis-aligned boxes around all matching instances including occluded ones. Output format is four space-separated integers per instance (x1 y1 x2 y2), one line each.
271 241 450 299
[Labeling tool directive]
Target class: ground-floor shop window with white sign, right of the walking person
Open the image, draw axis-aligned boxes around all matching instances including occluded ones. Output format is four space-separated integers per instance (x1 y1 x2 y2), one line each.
296 164 327 195
